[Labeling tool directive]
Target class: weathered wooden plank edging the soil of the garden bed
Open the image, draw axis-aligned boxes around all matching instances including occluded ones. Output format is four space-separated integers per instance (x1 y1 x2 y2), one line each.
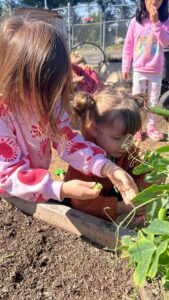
5 197 134 248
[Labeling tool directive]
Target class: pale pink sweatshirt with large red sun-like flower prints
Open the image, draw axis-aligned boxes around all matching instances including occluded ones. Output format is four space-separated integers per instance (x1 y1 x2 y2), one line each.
0 100 108 202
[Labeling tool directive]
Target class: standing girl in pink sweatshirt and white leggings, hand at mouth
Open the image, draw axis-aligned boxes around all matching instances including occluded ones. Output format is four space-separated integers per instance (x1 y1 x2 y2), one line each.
122 0 169 141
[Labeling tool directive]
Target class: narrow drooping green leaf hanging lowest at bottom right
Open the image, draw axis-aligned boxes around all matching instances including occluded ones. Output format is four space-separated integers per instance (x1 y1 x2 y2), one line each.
148 240 169 278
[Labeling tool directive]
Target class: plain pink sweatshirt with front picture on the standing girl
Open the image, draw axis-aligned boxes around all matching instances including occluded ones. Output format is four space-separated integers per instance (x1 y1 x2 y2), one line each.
122 18 169 73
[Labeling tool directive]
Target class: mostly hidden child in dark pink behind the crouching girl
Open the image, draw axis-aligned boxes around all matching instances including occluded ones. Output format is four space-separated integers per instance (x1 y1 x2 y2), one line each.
70 52 103 94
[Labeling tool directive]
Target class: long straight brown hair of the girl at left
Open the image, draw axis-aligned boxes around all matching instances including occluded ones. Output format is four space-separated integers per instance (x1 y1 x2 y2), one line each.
0 17 72 133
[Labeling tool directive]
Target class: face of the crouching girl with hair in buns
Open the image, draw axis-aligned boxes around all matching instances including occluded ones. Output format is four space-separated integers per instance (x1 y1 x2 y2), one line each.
95 119 133 158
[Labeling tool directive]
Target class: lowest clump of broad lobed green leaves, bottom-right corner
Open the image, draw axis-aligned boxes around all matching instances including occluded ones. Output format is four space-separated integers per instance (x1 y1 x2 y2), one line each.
121 219 169 289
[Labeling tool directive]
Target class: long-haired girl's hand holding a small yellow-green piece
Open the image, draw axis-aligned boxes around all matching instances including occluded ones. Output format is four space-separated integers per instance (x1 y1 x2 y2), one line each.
60 179 101 200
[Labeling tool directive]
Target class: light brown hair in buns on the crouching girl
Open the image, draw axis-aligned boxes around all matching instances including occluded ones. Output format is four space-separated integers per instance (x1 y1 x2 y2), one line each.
72 89 142 136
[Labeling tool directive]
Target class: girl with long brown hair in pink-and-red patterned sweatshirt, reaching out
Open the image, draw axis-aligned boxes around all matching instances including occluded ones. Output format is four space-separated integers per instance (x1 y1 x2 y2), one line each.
0 17 137 202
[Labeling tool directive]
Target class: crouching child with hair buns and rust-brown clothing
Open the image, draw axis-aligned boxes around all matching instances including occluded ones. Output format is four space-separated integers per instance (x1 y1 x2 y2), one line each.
65 89 148 219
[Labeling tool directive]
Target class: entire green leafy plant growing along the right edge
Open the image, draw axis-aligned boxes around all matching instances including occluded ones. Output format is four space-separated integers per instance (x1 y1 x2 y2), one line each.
120 145 169 289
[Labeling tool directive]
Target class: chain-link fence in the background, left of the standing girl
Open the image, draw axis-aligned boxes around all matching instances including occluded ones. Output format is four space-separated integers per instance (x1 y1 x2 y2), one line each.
54 4 136 55
